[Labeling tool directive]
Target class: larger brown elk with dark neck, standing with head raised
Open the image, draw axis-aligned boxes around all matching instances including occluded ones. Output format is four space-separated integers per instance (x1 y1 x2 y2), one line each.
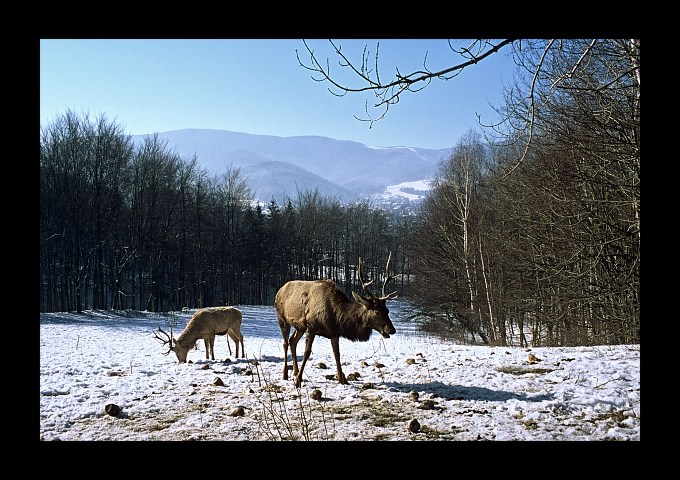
274 252 396 387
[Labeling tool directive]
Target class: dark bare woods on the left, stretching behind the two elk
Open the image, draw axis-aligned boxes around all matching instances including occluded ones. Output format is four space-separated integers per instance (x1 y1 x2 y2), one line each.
40 111 409 312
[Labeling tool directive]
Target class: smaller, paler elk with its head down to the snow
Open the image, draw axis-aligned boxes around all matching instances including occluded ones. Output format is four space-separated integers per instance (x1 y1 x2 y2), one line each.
155 307 246 363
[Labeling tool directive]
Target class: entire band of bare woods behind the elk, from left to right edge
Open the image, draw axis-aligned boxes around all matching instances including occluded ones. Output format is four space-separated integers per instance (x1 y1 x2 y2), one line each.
40 39 640 346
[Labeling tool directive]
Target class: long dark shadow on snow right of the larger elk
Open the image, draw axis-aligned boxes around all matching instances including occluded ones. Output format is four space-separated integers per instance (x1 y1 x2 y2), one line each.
385 381 554 402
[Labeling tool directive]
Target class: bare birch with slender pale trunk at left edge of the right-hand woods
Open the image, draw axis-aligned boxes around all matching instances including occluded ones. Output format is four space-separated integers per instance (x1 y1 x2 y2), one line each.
412 131 495 343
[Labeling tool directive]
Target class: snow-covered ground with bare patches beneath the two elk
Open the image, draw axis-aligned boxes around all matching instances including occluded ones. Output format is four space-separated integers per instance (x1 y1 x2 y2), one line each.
40 300 640 441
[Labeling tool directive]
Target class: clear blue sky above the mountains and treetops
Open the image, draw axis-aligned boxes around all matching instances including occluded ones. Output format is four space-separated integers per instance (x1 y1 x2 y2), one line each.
40 39 514 149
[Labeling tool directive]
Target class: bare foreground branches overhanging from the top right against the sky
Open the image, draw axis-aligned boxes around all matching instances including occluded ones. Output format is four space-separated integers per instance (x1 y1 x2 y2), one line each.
296 38 640 174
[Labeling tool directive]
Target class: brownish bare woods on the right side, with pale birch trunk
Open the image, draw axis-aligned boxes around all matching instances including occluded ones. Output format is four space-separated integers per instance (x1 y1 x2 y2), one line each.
407 40 640 346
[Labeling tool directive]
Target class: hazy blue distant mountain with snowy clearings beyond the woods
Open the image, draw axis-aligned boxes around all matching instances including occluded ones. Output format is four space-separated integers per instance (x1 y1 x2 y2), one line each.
132 129 451 203
